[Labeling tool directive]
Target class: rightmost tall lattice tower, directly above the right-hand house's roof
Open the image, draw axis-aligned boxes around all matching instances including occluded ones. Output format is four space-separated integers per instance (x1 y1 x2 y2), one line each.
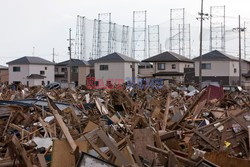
210 6 226 52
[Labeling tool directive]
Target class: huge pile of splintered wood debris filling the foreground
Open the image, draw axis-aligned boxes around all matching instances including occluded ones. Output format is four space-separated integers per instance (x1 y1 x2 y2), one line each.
0 85 250 167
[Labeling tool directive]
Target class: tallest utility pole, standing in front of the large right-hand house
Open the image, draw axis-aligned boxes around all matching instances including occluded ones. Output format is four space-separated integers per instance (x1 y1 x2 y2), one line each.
197 0 208 90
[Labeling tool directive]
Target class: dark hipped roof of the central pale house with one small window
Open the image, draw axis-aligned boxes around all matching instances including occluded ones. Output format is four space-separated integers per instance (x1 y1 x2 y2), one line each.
94 52 139 63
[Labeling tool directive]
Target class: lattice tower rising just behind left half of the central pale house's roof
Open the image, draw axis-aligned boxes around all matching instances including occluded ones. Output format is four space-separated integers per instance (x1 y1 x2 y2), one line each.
97 13 112 58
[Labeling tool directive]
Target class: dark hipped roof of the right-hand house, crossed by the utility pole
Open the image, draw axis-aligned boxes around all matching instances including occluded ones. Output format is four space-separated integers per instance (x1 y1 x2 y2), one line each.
193 50 239 61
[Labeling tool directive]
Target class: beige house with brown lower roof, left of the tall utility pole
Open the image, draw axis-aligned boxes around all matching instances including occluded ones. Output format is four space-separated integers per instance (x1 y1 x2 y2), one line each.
142 51 194 83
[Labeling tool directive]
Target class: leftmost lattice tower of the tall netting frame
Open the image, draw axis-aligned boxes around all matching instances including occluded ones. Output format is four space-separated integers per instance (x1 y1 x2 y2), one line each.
75 15 86 60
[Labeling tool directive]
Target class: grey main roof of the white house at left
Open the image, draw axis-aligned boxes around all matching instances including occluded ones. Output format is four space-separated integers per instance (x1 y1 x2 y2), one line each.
7 56 54 65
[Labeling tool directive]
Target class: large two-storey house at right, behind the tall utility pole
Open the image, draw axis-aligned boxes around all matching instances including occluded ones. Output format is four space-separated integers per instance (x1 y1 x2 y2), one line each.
193 50 246 85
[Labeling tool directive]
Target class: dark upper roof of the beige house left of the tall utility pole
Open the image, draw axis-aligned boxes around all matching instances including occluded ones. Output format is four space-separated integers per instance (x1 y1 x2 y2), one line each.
142 51 193 63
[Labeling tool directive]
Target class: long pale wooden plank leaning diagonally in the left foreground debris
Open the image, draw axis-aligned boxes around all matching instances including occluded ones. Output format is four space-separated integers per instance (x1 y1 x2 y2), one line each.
47 98 78 153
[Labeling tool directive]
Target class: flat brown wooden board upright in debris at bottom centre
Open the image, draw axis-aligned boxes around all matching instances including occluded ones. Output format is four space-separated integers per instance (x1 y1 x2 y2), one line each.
133 128 155 161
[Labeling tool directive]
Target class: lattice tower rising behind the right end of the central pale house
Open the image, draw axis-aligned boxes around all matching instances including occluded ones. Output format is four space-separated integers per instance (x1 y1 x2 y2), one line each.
132 11 147 60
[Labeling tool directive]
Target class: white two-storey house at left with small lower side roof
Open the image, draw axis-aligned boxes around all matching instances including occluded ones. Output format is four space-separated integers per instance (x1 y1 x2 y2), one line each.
7 56 55 86
